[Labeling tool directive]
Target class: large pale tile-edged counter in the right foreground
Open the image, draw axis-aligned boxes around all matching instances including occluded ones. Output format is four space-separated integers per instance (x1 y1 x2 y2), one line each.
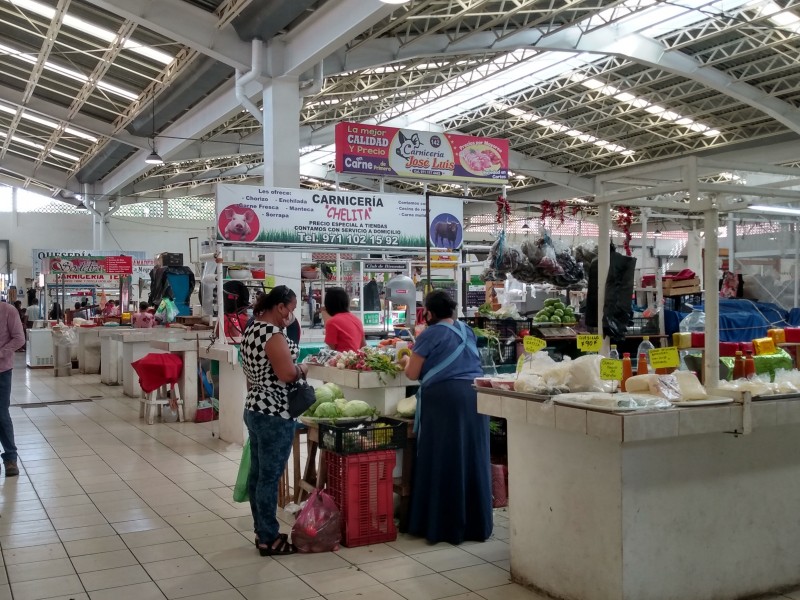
478 392 800 600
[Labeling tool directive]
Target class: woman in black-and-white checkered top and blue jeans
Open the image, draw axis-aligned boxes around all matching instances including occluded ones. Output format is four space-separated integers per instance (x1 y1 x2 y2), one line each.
240 285 308 556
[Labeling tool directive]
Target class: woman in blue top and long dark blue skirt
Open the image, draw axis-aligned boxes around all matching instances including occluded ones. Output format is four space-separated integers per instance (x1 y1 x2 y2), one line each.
405 290 492 544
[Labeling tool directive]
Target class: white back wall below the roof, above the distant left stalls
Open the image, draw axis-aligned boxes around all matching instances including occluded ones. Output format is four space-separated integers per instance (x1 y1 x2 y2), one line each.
0 213 214 269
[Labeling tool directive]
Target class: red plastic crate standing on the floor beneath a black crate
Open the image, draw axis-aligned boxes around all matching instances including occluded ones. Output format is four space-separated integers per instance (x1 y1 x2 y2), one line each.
326 450 397 548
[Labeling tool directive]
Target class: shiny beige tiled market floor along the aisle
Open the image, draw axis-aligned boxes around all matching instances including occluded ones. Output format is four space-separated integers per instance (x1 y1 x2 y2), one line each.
0 384 539 600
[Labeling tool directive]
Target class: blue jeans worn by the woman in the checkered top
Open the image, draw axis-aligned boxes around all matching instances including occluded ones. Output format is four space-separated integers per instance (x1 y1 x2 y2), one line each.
244 410 295 544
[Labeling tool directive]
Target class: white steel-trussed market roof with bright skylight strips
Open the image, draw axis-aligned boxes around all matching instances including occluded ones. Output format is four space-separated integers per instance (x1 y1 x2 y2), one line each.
0 0 800 209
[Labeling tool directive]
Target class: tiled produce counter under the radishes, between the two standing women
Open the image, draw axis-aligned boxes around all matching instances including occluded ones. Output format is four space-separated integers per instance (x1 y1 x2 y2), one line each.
308 365 419 416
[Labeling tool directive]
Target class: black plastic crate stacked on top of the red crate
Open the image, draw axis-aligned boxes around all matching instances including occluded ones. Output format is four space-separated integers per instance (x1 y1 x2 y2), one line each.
319 417 408 454
